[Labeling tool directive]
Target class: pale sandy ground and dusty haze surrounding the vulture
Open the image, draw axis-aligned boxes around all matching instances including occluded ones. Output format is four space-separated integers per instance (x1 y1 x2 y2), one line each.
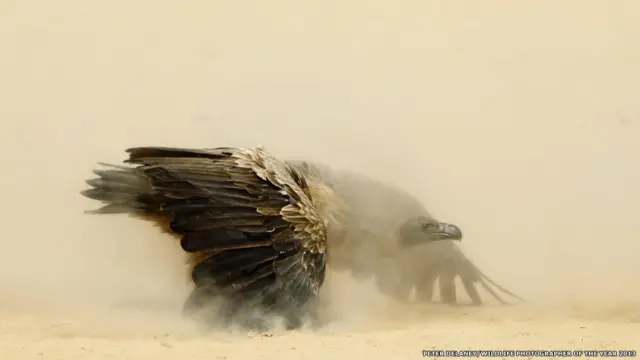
0 0 640 360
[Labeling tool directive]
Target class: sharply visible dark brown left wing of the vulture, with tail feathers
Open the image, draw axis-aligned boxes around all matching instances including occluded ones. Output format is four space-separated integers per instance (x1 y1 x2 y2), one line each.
83 147 326 320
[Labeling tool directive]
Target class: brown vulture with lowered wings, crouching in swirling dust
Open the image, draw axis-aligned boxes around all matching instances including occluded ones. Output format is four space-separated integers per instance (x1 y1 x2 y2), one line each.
82 147 520 329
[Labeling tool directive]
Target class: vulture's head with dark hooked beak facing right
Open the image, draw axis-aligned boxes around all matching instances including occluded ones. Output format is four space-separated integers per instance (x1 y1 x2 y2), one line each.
398 216 462 246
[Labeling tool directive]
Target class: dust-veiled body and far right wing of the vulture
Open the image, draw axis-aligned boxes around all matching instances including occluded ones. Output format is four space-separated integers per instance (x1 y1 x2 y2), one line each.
291 161 524 305
